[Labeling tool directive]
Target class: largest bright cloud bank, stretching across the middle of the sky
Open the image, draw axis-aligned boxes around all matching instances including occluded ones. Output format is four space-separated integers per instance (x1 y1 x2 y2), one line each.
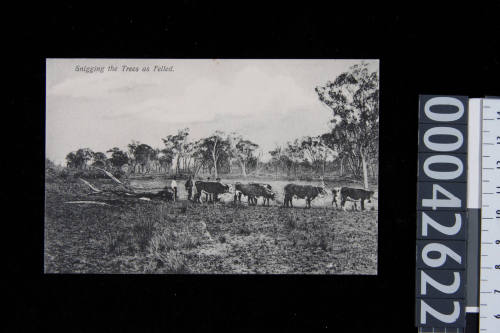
99 66 316 123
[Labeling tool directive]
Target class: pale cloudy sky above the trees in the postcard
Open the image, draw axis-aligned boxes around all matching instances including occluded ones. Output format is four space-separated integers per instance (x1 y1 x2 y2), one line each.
46 59 379 164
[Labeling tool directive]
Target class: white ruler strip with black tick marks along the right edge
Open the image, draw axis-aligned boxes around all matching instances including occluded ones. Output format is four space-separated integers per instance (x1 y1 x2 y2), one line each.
479 99 500 333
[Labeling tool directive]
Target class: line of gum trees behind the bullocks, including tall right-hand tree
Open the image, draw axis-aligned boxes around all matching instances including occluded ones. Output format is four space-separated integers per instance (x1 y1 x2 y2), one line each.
61 63 379 188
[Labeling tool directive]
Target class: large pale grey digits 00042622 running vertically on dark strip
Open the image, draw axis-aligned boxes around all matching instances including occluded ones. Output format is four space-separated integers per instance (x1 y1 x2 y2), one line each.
417 97 466 327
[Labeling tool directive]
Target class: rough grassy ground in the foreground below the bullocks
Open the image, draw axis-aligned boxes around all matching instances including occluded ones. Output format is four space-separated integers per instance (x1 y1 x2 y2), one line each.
45 175 378 274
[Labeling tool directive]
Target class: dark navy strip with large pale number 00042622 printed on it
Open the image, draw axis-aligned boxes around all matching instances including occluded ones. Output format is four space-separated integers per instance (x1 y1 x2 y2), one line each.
416 96 466 328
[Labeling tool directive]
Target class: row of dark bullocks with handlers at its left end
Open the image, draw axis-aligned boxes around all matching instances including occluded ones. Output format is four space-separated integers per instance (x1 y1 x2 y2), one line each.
164 177 374 210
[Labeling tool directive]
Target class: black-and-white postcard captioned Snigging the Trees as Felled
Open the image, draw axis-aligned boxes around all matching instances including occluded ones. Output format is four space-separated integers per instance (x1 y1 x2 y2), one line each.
43 58 380 275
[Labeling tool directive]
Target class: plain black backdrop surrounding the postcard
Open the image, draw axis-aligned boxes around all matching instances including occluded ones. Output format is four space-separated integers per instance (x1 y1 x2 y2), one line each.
7 1 500 332
